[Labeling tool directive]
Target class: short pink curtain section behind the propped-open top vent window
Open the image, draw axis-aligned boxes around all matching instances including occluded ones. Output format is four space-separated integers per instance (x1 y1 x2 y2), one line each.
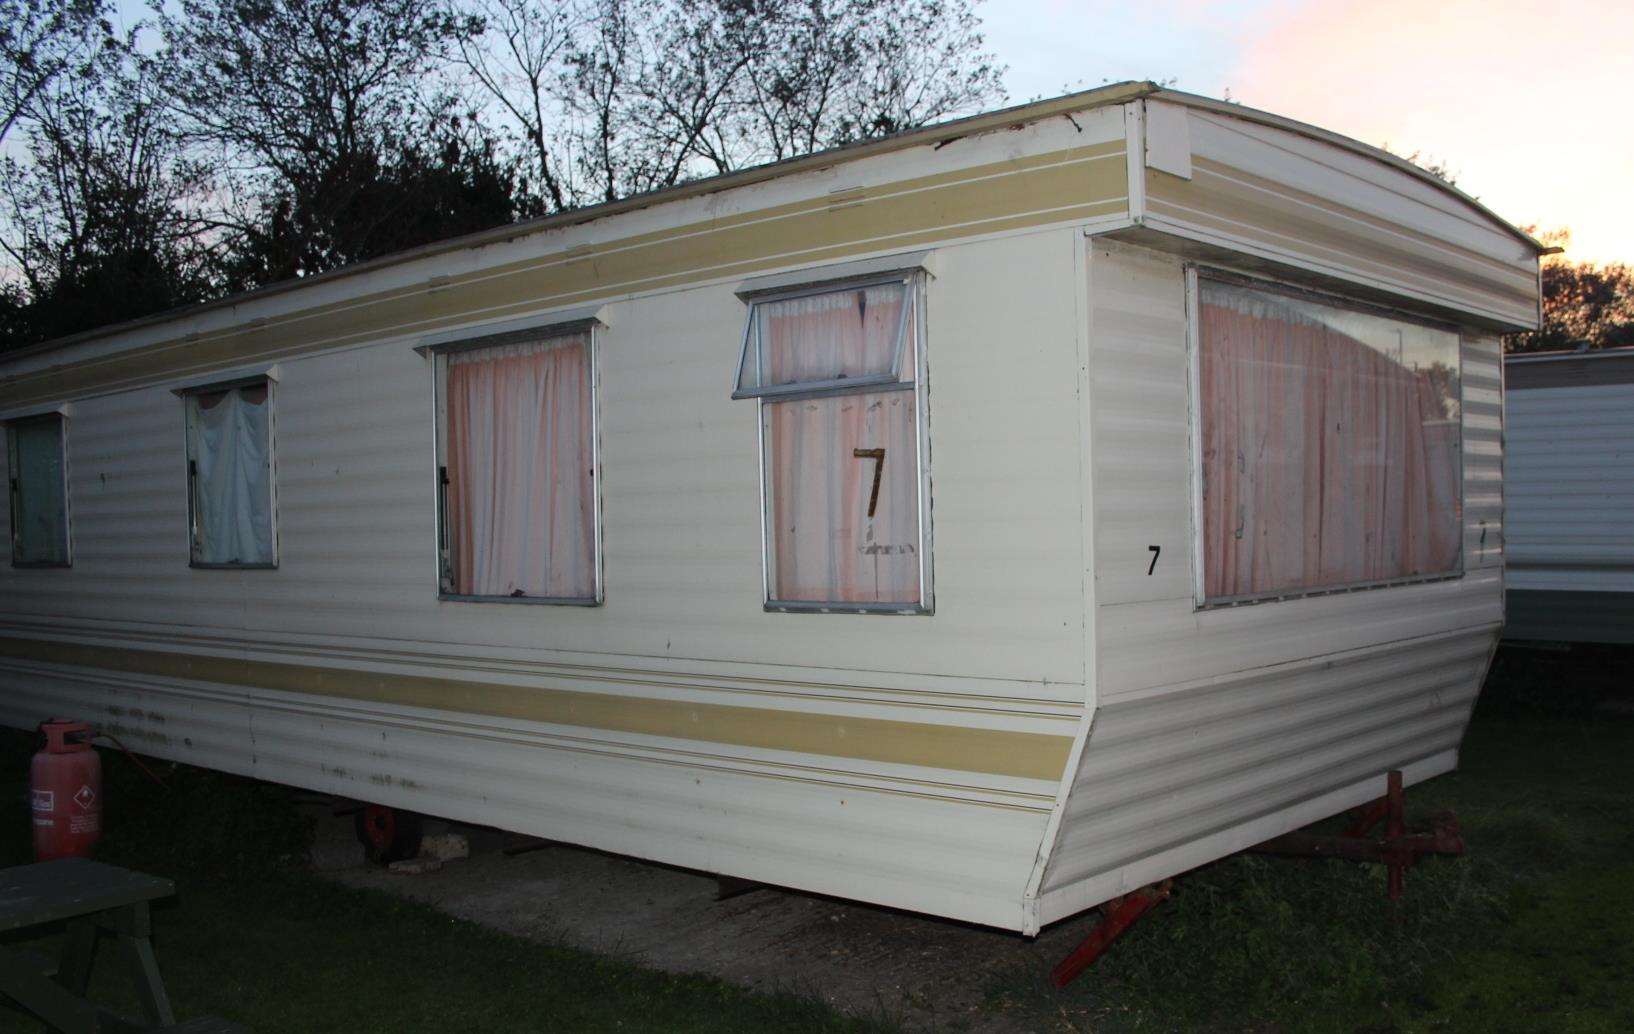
755 284 912 387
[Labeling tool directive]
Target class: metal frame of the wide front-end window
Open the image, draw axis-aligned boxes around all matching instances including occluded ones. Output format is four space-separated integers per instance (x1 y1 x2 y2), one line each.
1185 263 1469 611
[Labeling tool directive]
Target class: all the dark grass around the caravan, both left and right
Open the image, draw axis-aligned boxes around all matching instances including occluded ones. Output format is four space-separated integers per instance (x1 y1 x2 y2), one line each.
0 640 1634 1034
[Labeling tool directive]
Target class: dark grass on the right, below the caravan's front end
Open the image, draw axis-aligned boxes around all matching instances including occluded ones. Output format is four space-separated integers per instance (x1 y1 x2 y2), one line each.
989 665 1634 1032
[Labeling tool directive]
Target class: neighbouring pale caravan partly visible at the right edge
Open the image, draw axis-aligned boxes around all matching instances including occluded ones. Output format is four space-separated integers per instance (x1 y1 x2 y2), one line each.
1503 348 1634 644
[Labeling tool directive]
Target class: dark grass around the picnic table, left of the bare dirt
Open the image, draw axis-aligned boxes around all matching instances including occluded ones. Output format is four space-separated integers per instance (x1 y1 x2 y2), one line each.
0 732 881 1034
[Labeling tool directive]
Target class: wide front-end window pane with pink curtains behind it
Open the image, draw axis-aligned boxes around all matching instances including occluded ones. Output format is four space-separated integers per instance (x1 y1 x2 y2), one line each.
1196 276 1462 603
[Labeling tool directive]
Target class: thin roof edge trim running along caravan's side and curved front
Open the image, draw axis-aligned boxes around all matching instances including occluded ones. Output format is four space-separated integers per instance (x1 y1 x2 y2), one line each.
0 80 1559 364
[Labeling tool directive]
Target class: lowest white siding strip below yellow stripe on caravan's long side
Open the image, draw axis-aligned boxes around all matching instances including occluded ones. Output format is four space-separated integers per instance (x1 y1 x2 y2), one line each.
0 668 1044 928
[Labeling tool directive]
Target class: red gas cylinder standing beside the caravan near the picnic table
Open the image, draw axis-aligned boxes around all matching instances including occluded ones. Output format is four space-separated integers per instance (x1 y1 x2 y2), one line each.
28 719 101 861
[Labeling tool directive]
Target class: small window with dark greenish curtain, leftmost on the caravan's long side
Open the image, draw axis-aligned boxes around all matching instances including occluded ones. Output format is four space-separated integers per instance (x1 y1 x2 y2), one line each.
5 413 69 567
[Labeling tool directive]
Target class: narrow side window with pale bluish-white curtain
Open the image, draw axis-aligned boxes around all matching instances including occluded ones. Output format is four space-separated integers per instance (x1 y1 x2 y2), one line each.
183 379 278 567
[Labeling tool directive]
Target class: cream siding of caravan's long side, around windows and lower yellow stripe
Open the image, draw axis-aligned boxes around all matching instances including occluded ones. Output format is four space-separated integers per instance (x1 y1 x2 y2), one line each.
0 217 1085 928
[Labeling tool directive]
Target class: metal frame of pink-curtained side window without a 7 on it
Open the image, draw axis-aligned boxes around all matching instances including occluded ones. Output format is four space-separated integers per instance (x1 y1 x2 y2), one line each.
431 317 606 608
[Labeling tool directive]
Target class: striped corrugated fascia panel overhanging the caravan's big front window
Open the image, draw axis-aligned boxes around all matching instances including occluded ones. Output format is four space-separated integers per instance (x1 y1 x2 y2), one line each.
1145 101 1538 328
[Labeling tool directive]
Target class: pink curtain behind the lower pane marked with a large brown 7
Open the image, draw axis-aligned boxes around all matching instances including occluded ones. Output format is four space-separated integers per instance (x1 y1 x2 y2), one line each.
765 390 920 603
